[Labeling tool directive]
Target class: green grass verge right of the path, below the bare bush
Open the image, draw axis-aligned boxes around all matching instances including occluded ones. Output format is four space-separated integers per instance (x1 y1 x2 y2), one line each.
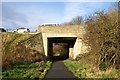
64 60 120 79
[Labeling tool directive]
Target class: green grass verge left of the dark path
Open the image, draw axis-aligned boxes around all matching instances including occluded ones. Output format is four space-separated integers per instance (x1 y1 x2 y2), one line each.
2 61 52 80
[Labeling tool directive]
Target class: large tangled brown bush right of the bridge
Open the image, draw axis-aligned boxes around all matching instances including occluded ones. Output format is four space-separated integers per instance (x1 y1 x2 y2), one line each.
77 4 120 71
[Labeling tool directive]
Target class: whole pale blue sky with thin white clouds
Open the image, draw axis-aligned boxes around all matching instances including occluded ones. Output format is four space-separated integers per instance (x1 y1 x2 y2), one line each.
0 0 117 30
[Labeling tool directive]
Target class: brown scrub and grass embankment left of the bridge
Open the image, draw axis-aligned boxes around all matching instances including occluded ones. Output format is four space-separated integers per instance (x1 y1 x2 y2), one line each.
2 32 46 68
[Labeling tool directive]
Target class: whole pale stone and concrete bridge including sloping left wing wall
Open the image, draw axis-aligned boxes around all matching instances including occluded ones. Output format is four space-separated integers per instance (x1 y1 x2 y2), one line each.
18 25 88 59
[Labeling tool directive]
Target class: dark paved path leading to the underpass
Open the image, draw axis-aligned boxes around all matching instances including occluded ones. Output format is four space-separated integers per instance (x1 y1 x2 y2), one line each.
43 61 78 80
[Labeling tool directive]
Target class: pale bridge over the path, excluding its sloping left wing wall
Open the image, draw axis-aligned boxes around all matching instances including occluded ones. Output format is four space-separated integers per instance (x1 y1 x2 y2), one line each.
38 25 85 59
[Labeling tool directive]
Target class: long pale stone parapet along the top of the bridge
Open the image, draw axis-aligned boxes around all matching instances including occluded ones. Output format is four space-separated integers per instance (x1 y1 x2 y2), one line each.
38 25 84 33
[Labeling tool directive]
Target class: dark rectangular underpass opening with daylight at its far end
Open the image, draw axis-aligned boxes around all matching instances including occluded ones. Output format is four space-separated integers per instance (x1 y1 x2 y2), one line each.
48 37 76 60
